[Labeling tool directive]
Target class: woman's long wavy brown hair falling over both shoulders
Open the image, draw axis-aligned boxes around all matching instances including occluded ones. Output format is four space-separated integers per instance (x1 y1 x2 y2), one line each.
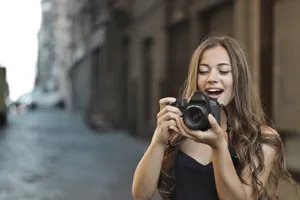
158 36 294 200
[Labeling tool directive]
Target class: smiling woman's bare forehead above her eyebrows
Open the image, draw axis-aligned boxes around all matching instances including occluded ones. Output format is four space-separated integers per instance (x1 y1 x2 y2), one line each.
200 45 231 65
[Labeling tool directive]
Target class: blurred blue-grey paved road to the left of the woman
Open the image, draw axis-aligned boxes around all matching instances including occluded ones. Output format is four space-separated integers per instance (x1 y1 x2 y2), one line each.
0 111 300 200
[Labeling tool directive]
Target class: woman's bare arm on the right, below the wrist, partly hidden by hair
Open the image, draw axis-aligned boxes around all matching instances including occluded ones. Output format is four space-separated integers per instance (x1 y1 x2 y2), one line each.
212 128 276 200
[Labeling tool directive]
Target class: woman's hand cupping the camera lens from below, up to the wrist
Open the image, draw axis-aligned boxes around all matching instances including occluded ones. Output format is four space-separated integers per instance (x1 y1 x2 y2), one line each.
172 114 226 149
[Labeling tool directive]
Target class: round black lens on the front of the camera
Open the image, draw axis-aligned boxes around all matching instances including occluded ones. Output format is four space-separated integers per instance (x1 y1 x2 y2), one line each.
183 105 207 130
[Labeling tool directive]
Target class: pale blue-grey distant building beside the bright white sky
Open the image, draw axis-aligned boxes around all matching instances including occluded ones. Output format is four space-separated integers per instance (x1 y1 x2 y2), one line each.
34 0 72 108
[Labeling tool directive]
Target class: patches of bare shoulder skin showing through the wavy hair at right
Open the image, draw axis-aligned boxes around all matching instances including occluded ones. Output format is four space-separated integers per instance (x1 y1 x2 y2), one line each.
260 126 280 161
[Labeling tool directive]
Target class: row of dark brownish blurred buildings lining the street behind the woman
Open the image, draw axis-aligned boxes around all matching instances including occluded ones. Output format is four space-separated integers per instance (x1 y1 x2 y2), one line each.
39 0 300 141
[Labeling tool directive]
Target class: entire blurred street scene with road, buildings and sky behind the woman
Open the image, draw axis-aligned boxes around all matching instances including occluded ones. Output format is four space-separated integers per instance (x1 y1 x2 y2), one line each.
0 0 300 200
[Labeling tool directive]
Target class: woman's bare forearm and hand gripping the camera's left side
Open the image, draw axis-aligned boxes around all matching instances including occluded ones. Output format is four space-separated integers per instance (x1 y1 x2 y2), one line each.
132 97 182 200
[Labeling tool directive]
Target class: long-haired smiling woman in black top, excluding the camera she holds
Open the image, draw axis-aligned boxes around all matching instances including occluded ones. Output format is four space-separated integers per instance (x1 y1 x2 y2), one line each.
132 36 292 200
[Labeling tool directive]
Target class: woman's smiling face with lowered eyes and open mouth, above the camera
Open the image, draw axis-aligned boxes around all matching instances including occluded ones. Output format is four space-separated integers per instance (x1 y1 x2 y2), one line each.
197 45 234 106
